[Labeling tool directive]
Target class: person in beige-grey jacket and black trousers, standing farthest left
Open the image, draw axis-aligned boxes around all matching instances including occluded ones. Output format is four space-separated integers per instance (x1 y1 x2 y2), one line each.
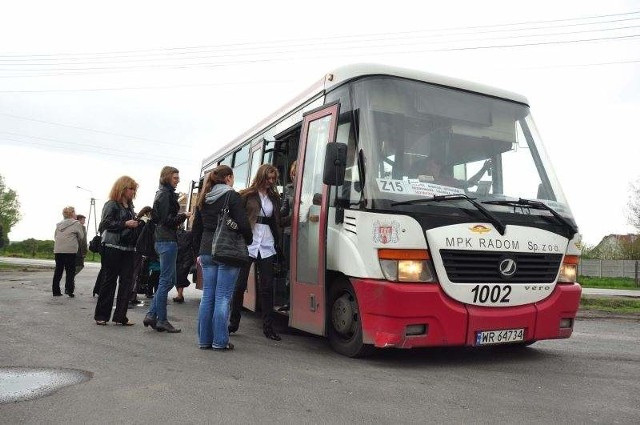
52 207 84 298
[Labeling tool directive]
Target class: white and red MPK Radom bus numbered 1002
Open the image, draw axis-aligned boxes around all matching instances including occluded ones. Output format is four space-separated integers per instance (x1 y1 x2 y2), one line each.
192 64 582 357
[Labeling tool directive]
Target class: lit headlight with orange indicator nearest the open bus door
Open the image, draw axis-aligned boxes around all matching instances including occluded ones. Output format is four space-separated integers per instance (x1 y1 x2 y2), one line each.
378 249 435 282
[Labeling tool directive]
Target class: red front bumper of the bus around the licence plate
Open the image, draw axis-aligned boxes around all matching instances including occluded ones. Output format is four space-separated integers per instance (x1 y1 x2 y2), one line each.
351 278 582 348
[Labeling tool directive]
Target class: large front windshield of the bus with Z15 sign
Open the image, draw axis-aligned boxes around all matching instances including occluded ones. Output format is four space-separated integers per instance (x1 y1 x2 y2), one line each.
352 77 571 217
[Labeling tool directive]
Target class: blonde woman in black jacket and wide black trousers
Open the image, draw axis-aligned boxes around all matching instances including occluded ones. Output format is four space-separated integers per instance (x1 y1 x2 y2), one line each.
94 176 138 326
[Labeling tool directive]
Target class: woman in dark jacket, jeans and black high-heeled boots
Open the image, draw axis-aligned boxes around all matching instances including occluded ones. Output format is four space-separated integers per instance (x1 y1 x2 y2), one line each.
142 165 191 333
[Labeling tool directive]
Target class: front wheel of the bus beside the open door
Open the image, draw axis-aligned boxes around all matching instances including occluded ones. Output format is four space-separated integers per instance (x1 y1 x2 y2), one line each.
329 280 373 357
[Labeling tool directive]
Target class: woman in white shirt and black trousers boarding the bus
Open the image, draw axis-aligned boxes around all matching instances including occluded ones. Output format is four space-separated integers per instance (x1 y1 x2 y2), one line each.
229 164 281 341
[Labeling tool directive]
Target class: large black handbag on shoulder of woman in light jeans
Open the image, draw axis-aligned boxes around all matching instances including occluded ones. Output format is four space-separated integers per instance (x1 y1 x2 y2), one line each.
211 191 251 264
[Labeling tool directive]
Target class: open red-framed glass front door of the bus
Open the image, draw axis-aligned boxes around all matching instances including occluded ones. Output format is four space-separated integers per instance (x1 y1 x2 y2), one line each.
289 103 340 335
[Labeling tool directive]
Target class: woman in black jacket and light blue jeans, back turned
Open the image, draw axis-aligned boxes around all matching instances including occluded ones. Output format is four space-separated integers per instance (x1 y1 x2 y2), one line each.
193 165 253 350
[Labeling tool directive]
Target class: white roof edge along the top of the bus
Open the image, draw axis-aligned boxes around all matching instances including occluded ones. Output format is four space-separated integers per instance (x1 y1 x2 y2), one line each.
202 63 529 168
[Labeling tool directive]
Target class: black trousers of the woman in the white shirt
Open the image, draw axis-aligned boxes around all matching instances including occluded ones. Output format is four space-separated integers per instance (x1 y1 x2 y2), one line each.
229 254 274 330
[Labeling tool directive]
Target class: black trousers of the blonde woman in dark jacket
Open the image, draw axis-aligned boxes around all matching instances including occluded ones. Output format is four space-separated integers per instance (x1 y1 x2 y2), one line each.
94 247 135 323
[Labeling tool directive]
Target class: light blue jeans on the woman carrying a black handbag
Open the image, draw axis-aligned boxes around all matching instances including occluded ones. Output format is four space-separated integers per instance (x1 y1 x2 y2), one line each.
198 255 240 348
